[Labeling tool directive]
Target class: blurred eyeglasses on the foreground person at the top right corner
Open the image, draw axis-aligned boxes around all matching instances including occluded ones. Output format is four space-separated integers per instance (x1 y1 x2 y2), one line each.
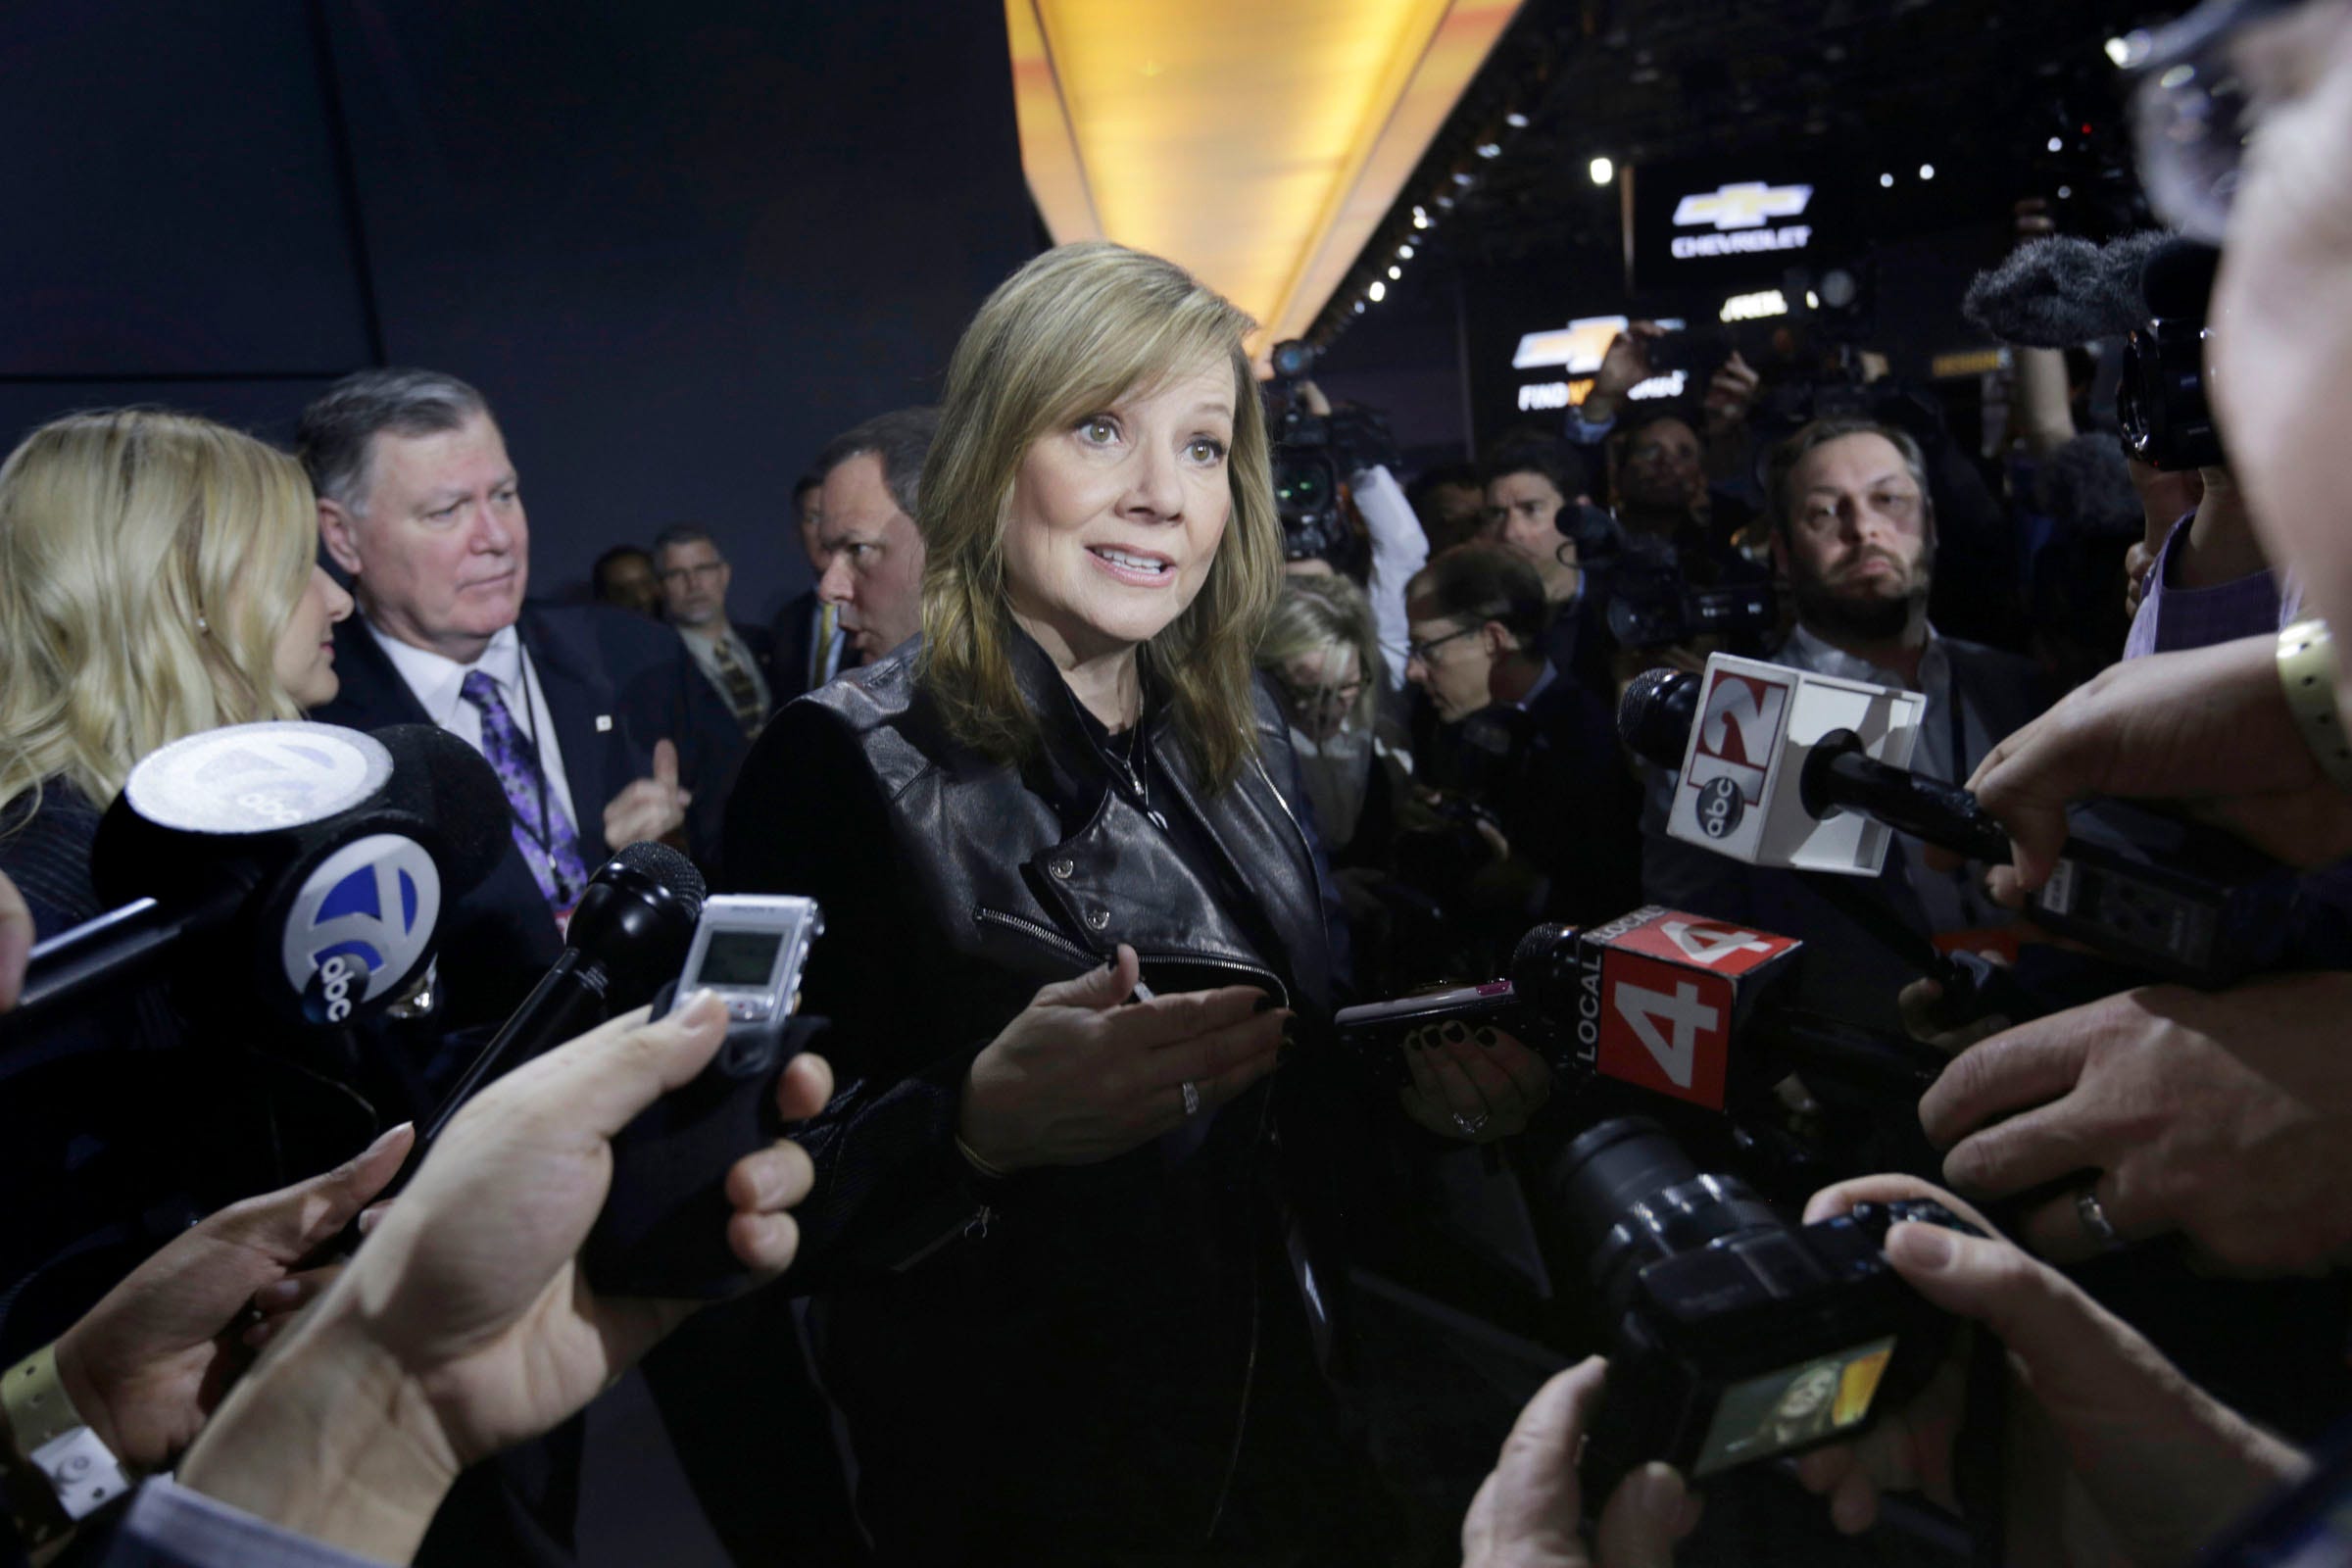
2127 0 2295 244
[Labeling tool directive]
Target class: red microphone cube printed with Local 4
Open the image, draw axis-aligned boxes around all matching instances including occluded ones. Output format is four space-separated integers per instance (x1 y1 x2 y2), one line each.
1574 906 1804 1112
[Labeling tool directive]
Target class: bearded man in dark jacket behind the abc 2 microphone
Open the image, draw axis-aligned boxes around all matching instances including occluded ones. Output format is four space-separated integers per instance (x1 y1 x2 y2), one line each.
1642 420 2048 1030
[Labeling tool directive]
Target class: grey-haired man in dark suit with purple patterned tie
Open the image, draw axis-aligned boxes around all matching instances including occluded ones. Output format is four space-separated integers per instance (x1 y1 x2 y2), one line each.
299 369 741 1027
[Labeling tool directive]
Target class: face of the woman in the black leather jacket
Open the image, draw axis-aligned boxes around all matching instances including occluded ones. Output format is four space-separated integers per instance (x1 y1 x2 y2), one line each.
1004 365 1235 661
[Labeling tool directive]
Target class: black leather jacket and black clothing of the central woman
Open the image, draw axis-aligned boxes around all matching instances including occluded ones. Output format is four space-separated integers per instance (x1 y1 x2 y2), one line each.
722 639 1395 1561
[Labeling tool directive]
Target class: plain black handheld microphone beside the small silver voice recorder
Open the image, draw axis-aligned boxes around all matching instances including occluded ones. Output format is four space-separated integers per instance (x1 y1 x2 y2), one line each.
423 846 706 1142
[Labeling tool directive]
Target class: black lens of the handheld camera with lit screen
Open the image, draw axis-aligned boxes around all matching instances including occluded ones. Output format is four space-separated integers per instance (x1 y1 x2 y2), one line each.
1547 1116 1788 1324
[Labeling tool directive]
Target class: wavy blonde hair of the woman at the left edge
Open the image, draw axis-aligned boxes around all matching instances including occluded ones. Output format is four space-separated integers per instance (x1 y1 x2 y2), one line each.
0 409 318 807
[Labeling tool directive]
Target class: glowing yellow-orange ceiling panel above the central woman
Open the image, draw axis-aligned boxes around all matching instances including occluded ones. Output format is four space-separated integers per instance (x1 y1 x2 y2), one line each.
1004 0 1519 355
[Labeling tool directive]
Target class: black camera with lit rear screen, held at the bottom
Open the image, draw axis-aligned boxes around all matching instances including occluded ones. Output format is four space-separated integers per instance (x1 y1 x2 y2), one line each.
1545 1116 1983 1507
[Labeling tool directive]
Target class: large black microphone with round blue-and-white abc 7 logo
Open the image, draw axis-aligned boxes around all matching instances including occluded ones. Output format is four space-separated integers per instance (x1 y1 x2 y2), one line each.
0 721 506 1039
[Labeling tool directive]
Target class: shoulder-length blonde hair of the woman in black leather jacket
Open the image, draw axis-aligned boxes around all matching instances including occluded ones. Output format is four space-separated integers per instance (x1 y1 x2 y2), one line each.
917 240 1282 790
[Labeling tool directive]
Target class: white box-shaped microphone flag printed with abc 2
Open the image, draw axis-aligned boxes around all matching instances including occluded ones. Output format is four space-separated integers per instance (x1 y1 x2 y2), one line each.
1665 654 1927 877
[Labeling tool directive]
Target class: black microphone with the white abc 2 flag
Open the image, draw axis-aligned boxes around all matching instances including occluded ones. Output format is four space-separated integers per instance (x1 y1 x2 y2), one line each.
1618 654 2298 990
